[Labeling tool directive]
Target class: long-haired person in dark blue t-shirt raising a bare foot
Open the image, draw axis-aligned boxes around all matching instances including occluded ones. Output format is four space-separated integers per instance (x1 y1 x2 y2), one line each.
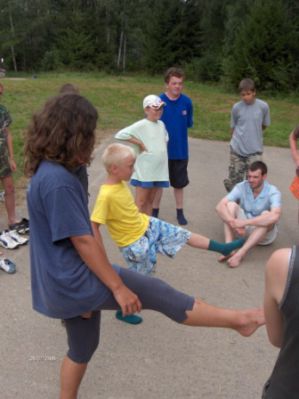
25 94 264 399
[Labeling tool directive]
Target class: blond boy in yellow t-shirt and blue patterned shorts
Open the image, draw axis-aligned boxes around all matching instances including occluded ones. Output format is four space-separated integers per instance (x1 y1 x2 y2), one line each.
91 143 244 274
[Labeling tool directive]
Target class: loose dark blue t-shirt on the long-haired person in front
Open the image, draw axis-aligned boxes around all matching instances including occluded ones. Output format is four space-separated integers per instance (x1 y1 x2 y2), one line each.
27 161 118 319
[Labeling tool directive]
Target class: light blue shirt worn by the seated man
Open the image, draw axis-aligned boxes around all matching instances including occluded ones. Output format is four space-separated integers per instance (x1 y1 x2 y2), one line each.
226 180 281 219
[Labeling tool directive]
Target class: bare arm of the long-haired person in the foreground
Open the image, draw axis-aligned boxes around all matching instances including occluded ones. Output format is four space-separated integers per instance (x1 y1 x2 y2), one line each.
70 235 141 316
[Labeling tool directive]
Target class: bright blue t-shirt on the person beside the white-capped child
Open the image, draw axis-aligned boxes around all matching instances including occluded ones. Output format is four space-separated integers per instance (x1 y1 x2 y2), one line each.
160 93 193 160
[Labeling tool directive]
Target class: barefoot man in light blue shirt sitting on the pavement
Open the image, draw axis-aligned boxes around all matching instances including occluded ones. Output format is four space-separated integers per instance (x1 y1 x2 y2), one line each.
216 161 281 267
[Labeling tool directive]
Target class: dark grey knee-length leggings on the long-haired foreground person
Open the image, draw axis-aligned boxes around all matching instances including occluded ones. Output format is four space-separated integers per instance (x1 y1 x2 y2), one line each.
65 268 194 363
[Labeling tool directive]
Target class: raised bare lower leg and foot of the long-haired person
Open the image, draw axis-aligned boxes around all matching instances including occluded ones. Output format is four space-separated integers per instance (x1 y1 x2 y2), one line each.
183 299 265 337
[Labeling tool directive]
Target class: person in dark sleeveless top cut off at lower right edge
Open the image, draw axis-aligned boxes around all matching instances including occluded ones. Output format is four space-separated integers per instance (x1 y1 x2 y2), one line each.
262 246 299 399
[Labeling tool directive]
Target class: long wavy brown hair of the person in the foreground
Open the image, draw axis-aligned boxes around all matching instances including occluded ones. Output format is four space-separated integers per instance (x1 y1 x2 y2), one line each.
25 94 98 176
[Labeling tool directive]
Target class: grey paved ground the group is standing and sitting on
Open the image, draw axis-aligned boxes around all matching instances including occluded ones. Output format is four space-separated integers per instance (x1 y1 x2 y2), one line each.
0 139 298 399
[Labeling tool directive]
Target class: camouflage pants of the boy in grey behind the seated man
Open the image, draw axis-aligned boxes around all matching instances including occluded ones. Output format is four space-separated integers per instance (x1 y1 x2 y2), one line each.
223 150 262 192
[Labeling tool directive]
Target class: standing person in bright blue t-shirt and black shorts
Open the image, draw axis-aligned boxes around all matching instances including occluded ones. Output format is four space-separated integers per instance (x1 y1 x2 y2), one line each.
152 67 193 225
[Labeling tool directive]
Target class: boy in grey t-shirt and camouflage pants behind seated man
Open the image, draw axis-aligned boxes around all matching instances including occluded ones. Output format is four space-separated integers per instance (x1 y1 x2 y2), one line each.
223 79 270 192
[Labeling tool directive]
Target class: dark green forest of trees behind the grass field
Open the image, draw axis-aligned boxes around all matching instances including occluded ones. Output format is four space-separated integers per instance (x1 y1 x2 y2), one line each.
0 0 299 91
